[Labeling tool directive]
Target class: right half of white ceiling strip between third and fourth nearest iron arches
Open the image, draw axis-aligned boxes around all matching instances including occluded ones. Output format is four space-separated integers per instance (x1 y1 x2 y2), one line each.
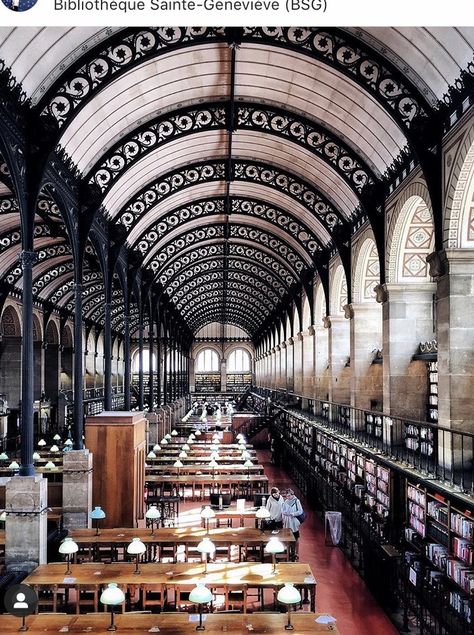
230 181 330 244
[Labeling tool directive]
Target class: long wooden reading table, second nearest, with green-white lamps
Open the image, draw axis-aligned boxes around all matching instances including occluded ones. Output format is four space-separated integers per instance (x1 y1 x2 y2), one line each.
23 562 316 611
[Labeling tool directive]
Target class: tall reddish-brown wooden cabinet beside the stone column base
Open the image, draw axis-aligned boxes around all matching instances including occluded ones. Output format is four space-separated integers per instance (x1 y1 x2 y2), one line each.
86 411 146 527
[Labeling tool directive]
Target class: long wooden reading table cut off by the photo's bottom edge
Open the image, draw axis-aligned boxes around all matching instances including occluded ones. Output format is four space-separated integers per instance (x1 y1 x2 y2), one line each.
0 613 339 635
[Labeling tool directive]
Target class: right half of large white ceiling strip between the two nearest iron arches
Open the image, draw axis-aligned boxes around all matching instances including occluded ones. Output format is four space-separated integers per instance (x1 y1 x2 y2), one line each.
236 45 406 172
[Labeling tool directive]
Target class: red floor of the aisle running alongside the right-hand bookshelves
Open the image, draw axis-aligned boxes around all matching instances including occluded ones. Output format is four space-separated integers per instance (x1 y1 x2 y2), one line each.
258 451 398 635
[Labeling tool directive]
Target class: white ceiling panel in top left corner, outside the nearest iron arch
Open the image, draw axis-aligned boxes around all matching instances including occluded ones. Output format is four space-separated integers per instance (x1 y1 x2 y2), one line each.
0 26 122 104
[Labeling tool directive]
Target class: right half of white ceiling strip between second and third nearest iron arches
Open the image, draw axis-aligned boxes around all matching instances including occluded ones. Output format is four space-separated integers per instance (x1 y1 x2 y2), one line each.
232 131 359 217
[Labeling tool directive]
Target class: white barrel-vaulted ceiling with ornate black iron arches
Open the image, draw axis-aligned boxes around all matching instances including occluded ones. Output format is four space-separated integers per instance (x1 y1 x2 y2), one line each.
0 27 474 336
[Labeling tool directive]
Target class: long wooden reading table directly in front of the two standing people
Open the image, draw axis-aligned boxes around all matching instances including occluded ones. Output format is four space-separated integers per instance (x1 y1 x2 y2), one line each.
69 527 295 562
